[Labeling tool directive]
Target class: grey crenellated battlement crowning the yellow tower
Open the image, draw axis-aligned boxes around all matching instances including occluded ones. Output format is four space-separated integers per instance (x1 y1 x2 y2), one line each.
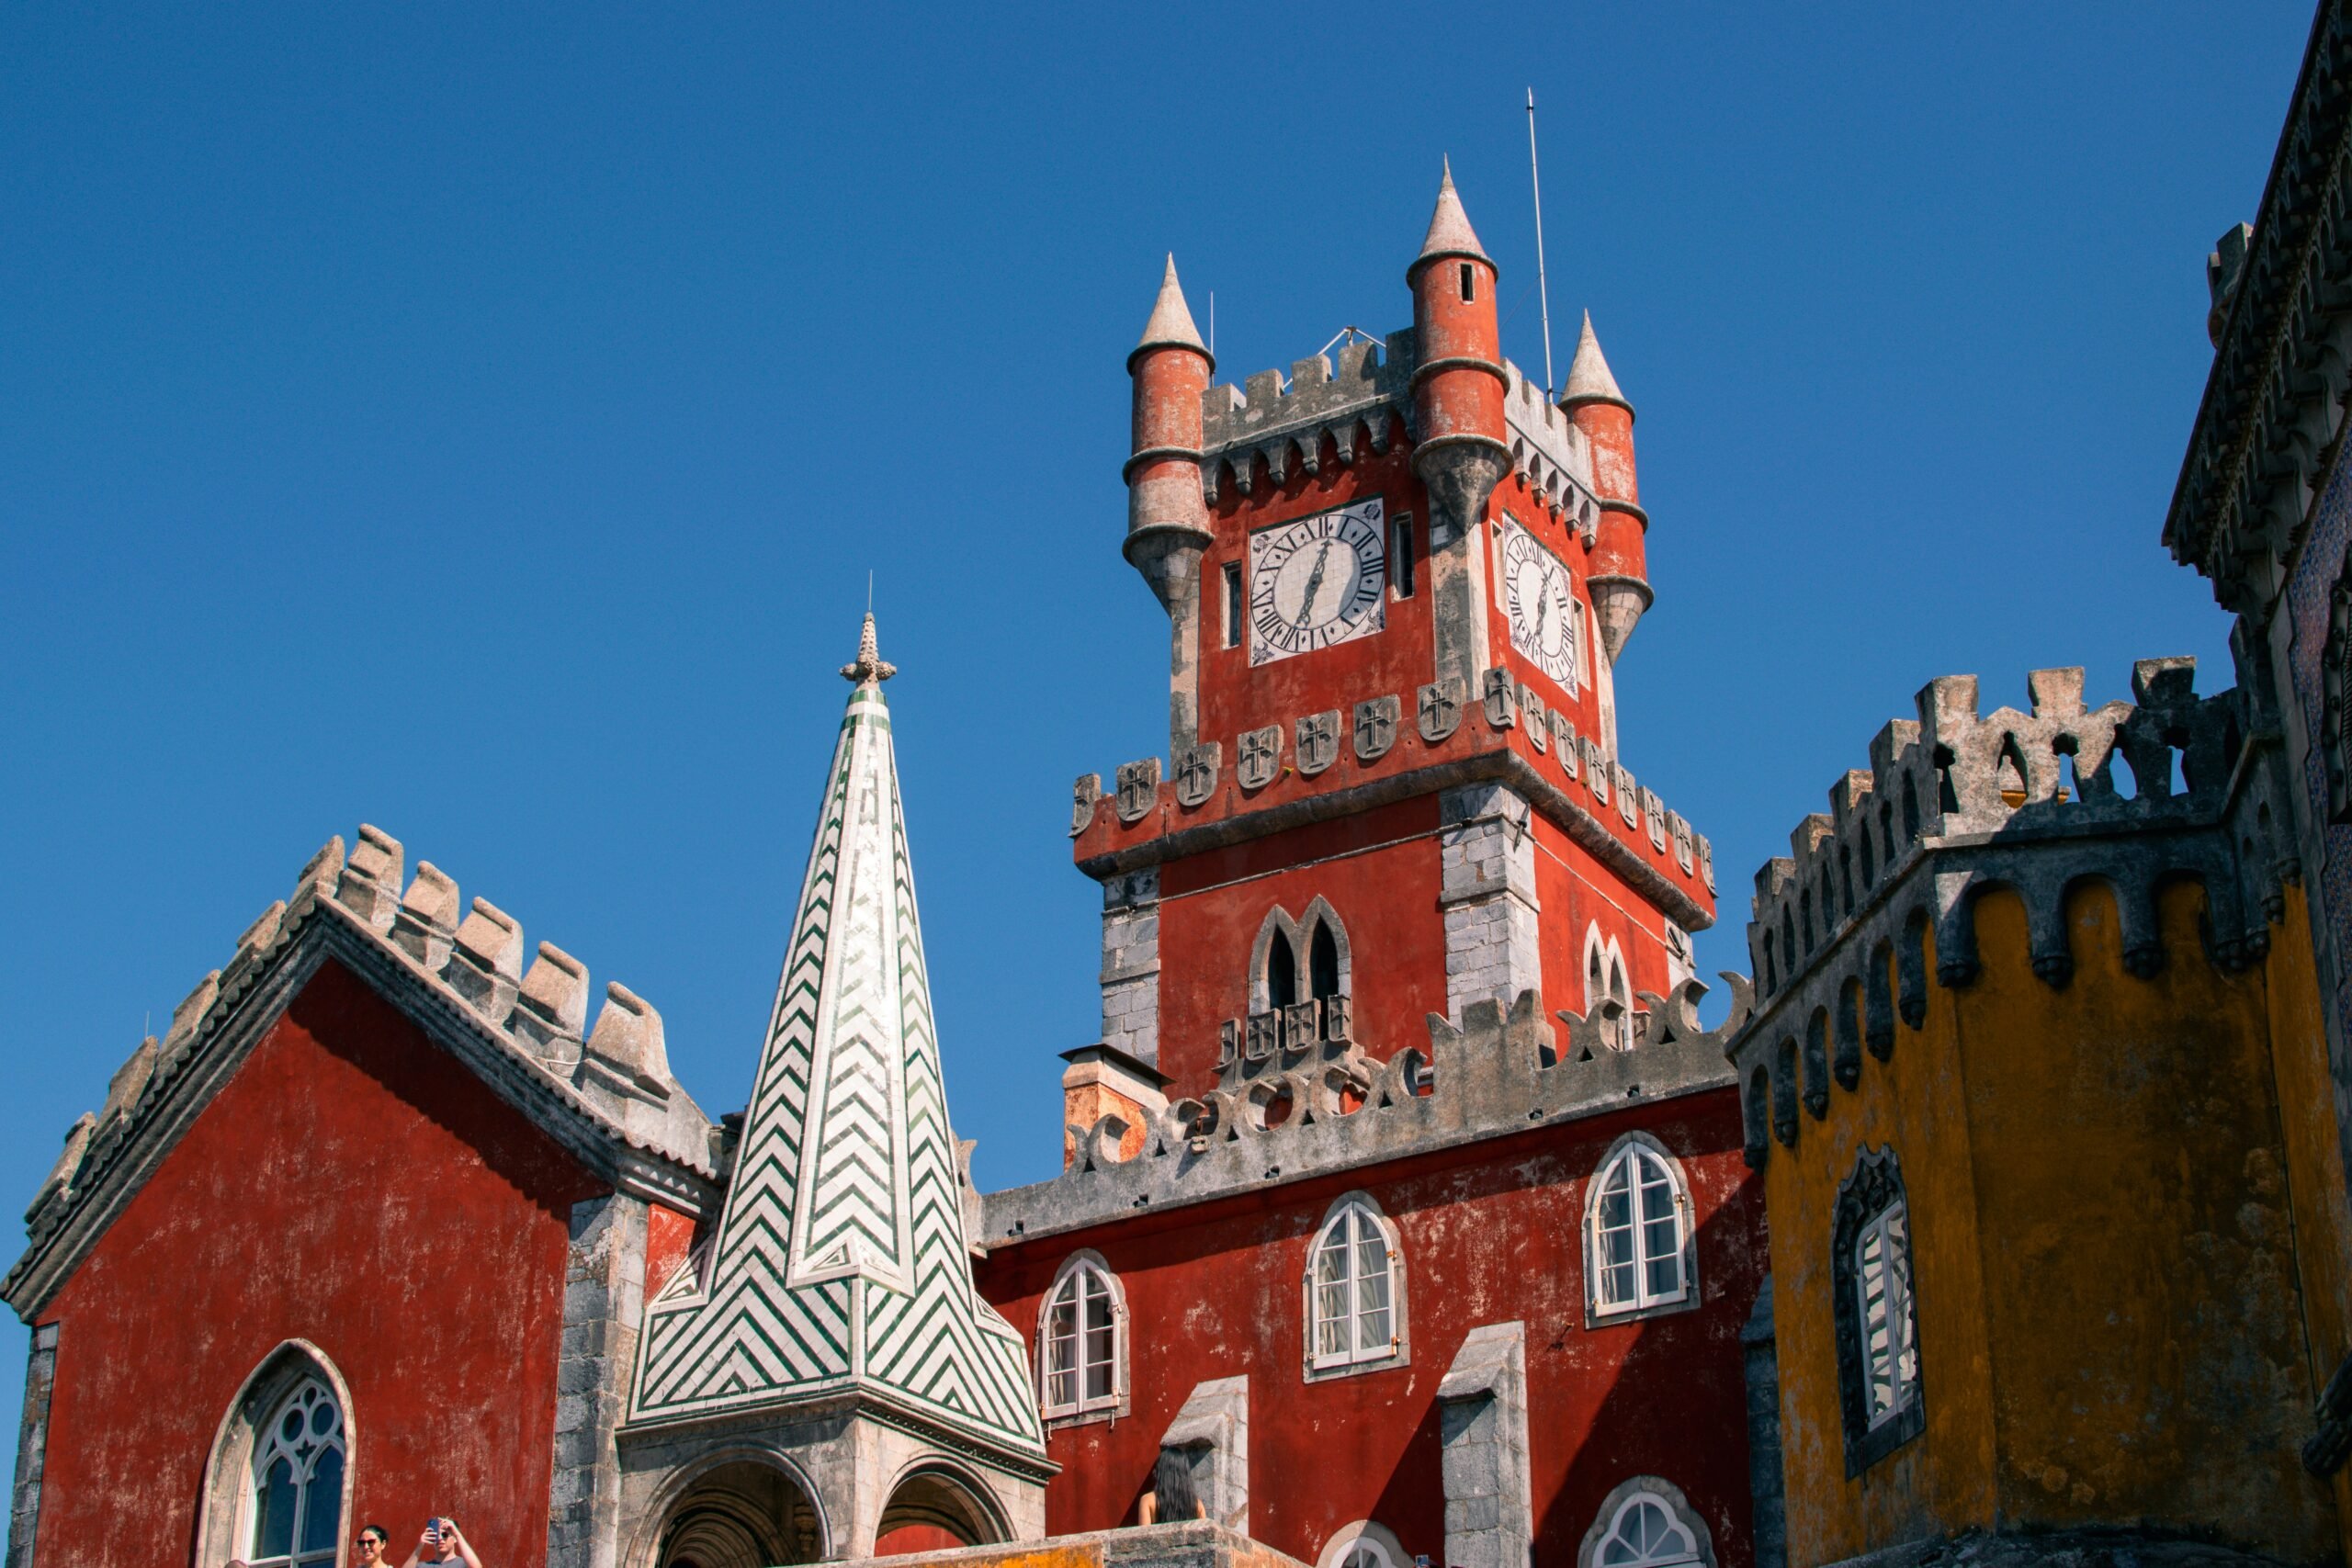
1731 659 2298 1164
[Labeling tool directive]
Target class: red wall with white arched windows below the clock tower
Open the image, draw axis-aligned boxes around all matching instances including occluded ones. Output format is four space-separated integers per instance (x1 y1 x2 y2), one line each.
981 1089 1764 1568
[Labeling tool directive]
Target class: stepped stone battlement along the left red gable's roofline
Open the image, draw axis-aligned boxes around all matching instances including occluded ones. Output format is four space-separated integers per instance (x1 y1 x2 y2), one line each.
0 825 719 1303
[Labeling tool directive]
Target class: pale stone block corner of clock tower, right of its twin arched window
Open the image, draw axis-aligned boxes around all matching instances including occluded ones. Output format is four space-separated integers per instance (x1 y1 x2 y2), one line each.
1437 783 1543 1022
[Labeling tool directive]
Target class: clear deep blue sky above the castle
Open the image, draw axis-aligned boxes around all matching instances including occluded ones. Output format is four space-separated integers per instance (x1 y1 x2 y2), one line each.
0 0 2310 1506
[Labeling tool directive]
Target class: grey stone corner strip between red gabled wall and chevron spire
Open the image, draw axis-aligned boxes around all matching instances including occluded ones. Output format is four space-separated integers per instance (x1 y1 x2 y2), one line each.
545 1194 647 1568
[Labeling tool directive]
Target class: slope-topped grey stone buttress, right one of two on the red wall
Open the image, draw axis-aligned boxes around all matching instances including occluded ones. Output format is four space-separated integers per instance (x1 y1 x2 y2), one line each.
1437 1324 1536 1568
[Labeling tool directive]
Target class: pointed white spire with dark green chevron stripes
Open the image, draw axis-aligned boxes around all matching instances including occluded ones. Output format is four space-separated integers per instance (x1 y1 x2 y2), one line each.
630 616 1045 1460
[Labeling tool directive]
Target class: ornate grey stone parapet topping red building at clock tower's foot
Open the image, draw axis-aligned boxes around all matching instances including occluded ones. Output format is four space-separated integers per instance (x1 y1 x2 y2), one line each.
981 974 1750 1244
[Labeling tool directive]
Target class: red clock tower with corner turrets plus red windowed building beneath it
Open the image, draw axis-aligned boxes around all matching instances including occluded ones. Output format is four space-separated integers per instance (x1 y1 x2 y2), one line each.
976 172 1778 1568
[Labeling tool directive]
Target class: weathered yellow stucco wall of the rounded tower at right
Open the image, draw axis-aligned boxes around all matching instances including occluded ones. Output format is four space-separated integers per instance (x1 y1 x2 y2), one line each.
1767 884 2352 1565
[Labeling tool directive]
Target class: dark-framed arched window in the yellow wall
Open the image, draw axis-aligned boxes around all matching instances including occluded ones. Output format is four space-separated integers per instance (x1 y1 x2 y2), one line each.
1830 1149 1927 1476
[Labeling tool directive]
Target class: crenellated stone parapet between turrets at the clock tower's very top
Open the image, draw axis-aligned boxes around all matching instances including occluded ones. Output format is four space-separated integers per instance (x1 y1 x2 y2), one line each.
1200 327 1600 526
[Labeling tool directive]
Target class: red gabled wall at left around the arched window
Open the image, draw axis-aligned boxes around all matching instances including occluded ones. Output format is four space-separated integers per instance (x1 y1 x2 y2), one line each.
35 964 600 1568
